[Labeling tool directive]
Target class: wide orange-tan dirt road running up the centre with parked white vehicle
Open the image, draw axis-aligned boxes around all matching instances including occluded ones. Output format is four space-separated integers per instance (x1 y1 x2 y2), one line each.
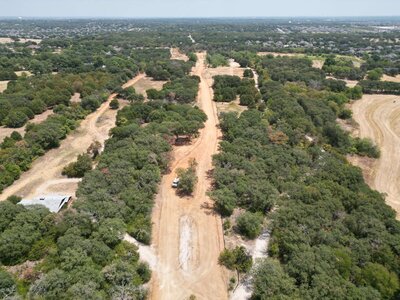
151 53 228 300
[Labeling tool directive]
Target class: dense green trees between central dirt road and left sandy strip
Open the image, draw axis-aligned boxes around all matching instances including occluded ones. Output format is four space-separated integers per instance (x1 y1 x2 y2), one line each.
0 102 206 299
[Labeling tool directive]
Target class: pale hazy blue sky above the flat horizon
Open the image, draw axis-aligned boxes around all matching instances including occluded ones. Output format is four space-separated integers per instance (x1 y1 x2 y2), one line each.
0 0 400 18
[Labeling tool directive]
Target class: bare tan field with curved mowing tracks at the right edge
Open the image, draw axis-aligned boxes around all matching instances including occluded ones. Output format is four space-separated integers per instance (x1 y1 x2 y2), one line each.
351 95 400 219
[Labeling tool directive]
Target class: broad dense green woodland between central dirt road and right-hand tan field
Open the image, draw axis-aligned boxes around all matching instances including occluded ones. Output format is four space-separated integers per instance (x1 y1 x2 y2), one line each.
211 55 400 299
